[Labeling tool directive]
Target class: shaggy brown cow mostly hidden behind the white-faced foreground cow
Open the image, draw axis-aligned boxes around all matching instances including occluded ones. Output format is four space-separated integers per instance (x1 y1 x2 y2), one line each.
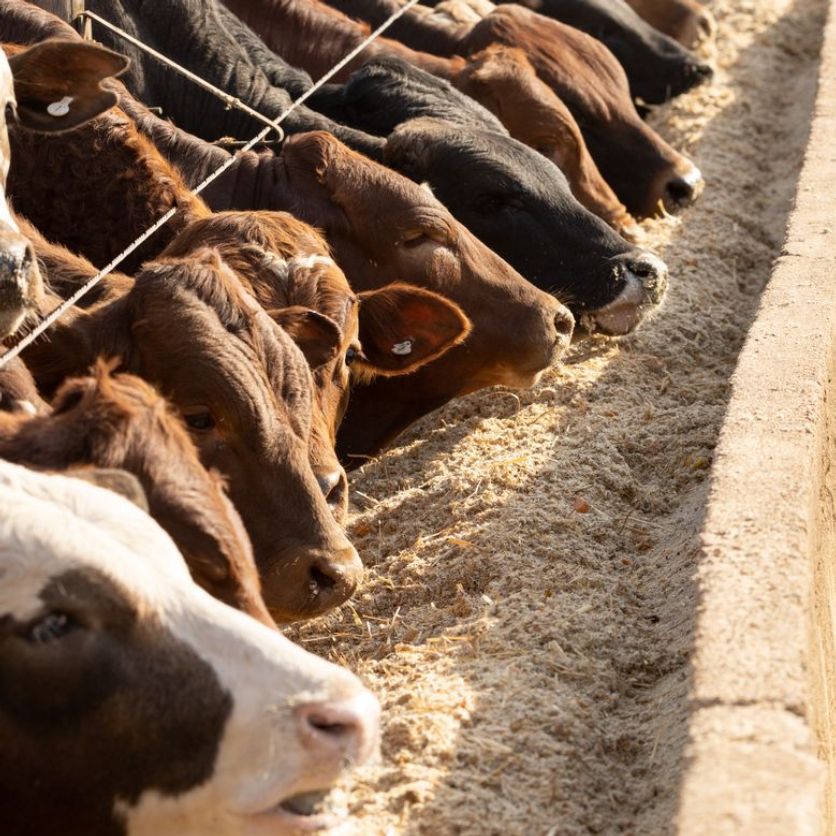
0 362 273 626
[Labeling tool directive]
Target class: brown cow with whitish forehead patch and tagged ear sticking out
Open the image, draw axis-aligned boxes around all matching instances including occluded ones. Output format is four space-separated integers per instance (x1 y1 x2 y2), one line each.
163 211 470 521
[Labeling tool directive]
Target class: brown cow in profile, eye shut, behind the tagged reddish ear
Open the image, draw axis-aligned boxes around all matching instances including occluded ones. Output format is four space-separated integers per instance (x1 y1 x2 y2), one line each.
196 132 572 463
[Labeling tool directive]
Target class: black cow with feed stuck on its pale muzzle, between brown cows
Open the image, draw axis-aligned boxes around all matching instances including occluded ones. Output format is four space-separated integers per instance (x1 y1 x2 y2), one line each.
312 58 667 334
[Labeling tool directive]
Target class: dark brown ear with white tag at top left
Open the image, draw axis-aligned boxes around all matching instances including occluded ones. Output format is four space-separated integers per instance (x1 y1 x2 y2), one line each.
9 40 129 133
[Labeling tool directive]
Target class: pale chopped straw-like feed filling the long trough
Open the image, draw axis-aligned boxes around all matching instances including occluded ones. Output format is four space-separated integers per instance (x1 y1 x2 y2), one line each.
294 0 829 836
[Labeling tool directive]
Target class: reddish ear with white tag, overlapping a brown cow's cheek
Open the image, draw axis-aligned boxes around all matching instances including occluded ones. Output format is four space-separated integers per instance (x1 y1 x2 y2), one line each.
360 284 471 375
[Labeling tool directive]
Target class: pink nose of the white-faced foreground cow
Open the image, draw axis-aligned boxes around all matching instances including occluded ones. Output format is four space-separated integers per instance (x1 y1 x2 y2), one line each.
296 689 380 765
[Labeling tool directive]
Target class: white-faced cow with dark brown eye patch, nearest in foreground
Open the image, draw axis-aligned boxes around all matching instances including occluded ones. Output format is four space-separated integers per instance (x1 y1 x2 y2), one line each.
0 462 379 836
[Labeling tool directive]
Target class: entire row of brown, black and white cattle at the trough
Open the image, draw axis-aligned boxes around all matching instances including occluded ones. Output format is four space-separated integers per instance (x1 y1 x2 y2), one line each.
0 0 714 836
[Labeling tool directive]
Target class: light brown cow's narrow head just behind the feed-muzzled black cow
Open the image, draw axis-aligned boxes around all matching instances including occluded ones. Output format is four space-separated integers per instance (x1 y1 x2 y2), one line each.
455 46 644 241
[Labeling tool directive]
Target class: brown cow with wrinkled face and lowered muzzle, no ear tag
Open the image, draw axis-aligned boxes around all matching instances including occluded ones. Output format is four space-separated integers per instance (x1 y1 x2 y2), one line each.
24 250 362 621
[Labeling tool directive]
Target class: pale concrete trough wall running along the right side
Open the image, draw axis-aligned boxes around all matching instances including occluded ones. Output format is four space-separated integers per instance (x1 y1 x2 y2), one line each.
677 2 836 836
